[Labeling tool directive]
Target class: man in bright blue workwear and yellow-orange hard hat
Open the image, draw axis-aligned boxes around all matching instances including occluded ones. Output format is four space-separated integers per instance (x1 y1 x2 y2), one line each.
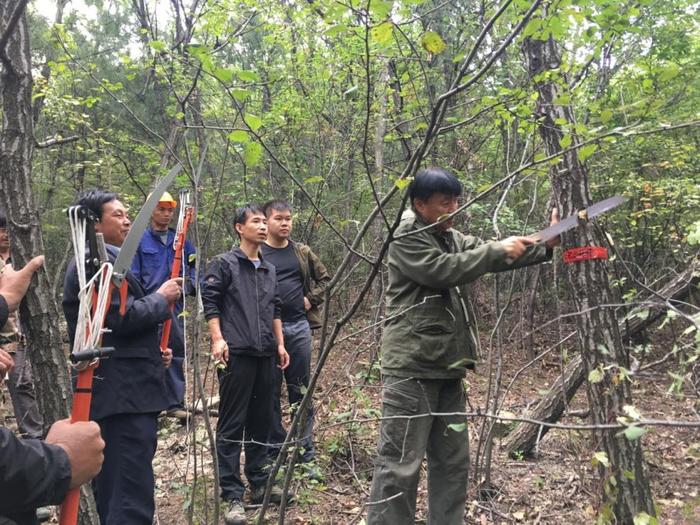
131 191 195 420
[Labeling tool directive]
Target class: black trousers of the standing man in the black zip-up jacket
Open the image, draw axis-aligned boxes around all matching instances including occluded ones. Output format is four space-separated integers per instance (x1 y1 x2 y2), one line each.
216 355 277 501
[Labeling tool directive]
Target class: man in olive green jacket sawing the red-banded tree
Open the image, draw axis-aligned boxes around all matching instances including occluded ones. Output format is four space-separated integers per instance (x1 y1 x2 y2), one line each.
368 168 558 525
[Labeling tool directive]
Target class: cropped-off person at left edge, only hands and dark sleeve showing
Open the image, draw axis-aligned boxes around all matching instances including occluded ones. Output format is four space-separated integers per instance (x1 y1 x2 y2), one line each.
0 256 104 525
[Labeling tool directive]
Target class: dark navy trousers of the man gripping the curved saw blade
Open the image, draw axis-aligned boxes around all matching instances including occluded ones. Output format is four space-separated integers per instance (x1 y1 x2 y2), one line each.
93 413 158 525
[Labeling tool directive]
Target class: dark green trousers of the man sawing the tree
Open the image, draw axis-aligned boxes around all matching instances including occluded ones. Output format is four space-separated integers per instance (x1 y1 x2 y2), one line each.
367 376 469 525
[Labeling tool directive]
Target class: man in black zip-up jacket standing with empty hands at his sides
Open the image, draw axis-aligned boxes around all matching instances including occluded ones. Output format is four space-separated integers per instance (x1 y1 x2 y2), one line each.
202 204 289 525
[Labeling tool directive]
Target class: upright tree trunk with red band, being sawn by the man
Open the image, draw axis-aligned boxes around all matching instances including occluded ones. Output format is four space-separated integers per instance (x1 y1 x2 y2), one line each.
524 35 655 523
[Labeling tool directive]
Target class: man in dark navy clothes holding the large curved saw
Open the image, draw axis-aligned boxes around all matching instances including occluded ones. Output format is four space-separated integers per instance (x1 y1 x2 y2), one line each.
63 190 180 525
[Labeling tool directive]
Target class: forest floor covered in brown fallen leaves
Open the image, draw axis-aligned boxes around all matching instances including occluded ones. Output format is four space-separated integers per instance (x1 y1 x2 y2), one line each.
0 314 700 525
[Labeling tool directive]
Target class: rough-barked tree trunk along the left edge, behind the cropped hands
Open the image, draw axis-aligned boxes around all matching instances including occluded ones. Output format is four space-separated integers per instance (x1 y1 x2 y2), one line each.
0 0 98 524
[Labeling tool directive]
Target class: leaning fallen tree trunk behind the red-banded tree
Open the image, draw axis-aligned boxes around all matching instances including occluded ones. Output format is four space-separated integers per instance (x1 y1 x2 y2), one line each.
503 260 700 457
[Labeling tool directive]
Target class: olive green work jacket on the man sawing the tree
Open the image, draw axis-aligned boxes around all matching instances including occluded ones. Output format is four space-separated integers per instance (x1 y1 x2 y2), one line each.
382 214 551 379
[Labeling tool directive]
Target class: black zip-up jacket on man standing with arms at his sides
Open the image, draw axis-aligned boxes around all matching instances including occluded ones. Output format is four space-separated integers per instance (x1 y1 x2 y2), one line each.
202 247 282 356
